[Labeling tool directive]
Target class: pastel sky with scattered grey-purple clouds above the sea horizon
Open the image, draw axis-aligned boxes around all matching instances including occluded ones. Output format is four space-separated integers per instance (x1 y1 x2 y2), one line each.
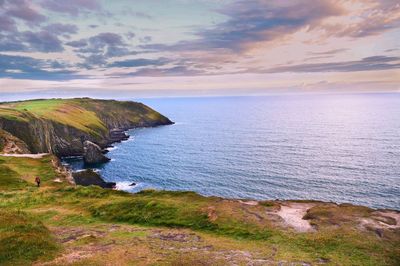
0 0 400 100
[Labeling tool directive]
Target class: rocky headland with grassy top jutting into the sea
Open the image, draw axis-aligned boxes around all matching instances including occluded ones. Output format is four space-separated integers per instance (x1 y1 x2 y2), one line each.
0 98 172 156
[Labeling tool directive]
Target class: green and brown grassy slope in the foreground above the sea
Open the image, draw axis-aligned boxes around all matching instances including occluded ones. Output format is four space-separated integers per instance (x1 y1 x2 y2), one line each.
0 157 400 265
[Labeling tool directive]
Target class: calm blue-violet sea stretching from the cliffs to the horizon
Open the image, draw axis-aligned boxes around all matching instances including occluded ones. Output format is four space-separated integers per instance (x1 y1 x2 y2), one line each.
65 94 400 209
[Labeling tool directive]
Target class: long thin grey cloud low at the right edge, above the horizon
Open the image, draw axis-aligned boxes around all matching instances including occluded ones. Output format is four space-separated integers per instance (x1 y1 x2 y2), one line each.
265 56 400 73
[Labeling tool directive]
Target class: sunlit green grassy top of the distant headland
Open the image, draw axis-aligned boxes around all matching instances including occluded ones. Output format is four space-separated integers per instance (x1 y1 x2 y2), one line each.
0 98 168 136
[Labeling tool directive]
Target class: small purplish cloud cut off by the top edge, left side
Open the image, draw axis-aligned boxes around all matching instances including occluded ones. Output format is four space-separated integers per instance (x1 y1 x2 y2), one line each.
41 0 101 16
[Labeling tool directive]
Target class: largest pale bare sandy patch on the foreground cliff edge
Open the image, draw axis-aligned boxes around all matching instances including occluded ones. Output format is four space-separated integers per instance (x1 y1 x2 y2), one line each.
276 203 315 232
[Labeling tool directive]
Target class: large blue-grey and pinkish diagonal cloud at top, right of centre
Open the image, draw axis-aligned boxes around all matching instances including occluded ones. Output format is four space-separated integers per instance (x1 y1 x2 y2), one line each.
142 0 343 53
